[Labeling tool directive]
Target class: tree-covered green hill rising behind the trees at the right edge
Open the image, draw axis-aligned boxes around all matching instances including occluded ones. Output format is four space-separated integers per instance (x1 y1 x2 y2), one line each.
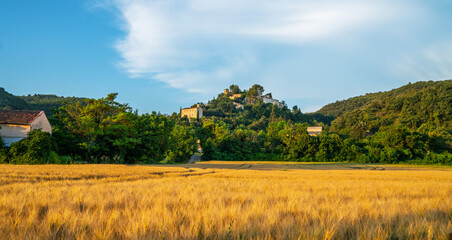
326 80 452 138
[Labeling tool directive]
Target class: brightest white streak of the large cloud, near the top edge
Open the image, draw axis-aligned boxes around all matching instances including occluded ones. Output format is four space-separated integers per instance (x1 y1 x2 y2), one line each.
237 2 400 42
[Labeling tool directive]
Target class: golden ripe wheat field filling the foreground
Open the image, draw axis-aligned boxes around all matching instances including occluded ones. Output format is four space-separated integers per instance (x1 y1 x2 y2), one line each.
0 163 452 239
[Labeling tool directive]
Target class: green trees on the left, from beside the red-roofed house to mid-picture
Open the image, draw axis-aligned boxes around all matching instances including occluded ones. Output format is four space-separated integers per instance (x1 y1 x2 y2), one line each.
0 93 196 164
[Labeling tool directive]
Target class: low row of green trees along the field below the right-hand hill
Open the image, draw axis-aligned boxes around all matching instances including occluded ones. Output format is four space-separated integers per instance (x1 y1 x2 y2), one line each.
198 120 452 164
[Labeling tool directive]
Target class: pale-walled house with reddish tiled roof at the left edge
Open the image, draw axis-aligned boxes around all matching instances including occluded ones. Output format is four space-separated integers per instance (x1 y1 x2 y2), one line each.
0 110 52 146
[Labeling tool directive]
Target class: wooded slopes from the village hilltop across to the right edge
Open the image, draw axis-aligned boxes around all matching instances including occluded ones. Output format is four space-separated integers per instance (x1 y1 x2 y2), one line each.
194 80 452 164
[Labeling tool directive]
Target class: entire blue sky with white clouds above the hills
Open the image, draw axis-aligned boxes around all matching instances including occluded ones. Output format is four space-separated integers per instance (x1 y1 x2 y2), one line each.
0 0 452 113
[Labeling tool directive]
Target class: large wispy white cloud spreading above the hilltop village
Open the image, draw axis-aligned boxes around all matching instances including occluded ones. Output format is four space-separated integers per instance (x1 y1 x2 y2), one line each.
106 0 416 92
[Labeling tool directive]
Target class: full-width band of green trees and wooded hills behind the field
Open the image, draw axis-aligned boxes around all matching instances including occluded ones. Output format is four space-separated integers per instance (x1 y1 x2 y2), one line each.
0 80 452 164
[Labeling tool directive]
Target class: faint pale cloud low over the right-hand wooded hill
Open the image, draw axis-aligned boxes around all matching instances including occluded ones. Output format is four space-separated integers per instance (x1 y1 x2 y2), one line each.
394 42 452 81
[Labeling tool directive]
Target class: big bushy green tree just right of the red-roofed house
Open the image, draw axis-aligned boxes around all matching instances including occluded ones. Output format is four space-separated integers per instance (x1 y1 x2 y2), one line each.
55 93 139 163
